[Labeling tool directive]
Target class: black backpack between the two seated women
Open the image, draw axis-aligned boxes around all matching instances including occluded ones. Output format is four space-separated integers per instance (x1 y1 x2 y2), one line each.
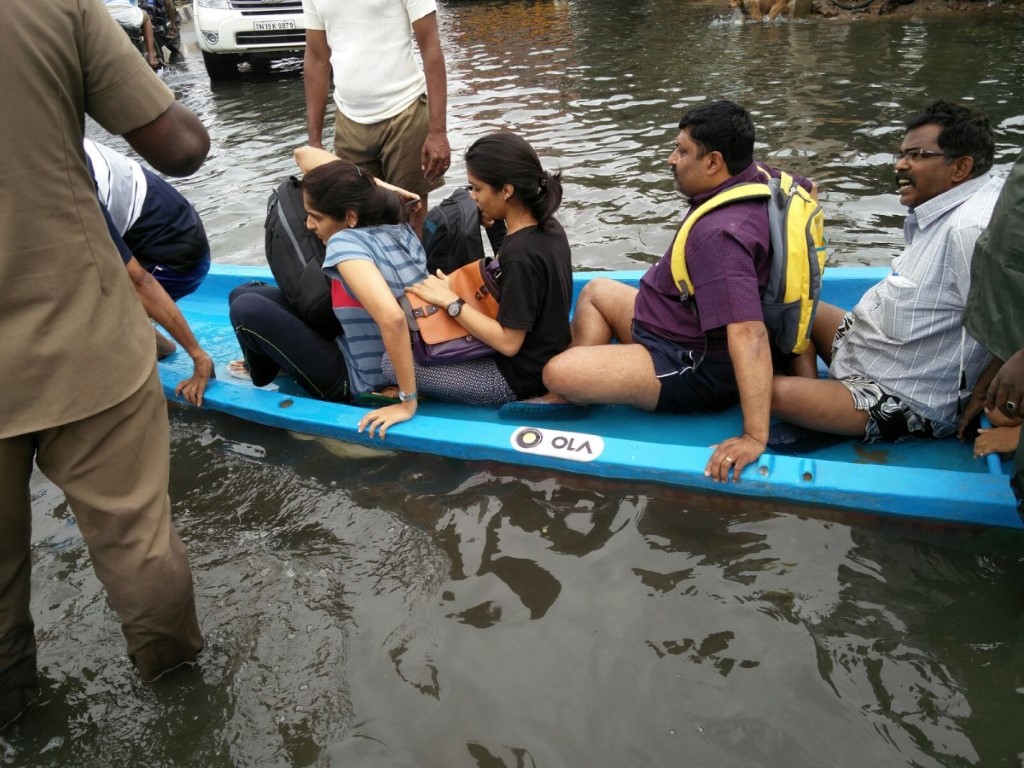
423 188 505 274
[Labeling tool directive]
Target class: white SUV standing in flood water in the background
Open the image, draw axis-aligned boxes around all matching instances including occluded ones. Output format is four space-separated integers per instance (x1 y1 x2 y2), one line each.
193 0 306 80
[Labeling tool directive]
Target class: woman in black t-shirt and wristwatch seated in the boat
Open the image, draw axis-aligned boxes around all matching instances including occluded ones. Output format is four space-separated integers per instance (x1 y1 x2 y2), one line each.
385 132 572 406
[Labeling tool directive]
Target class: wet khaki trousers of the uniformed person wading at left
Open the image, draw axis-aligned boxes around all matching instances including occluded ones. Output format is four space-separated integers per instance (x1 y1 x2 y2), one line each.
0 366 203 727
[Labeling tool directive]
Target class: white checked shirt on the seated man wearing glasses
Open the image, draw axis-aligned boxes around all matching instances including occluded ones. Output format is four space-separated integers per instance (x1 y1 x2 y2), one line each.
829 174 1002 428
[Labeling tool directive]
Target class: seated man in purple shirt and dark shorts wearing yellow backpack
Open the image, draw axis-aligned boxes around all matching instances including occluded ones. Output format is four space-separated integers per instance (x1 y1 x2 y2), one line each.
544 101 813 481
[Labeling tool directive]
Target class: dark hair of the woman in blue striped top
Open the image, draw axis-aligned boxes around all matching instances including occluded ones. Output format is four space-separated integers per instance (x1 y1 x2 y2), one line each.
302 160 408 227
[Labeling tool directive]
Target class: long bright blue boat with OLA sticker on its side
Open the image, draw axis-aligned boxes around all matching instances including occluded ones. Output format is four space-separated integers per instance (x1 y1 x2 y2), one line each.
160 264 1024 529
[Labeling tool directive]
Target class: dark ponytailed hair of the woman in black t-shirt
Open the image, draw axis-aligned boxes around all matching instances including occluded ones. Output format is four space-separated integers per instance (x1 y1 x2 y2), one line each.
466 131 562 228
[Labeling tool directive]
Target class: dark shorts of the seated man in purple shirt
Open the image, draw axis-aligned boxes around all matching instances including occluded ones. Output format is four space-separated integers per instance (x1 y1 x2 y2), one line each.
633 322 739 414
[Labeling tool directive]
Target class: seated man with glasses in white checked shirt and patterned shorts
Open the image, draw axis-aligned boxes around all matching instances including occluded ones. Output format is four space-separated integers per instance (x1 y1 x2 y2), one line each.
772 101 1002 442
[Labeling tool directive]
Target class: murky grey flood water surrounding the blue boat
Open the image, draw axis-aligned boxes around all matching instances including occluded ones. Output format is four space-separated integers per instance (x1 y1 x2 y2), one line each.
8 0 1024 768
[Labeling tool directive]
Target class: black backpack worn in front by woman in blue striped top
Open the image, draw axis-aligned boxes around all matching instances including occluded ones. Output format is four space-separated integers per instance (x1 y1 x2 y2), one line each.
264 176 341 339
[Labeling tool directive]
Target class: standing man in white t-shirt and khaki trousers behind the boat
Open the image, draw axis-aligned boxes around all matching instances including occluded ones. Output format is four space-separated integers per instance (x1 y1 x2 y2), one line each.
302 0 452 233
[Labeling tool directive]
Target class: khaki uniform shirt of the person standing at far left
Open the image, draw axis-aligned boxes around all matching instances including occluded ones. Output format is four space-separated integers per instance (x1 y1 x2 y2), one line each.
0 0 174 438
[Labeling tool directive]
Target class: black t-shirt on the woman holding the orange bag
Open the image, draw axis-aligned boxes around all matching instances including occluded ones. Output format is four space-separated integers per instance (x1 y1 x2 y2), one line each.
494 219 572 399
